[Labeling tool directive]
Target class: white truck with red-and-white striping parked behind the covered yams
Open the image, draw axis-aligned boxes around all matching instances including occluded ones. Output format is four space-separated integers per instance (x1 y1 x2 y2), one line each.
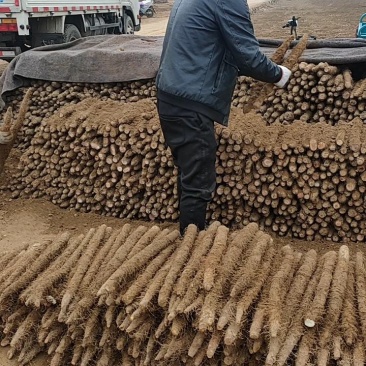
0 0 141 59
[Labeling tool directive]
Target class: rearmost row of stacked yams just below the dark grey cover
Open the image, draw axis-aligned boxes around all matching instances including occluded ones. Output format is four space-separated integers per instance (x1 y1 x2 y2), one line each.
7 60 366 150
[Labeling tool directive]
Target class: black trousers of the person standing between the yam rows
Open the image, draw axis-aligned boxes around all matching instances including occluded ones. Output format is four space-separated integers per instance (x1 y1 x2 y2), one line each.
158 101 217 234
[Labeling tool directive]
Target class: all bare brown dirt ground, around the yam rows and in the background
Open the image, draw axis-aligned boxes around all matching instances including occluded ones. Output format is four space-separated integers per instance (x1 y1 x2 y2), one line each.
0 0 366 366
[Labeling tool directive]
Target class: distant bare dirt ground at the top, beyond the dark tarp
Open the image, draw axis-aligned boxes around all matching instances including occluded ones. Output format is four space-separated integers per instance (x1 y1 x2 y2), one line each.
139 0 366 39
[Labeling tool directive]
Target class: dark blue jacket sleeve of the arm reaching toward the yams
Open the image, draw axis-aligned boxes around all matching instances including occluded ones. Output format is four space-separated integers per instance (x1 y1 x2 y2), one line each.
216 0 281 83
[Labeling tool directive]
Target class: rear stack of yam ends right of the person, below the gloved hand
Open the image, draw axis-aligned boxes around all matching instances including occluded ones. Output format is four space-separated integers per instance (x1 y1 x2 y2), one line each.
232 62 366 125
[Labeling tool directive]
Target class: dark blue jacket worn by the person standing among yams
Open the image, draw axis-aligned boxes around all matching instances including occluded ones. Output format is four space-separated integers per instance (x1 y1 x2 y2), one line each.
156 0 281 125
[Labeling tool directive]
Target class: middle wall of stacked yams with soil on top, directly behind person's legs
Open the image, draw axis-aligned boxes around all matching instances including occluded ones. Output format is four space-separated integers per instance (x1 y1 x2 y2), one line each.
7 99 366 241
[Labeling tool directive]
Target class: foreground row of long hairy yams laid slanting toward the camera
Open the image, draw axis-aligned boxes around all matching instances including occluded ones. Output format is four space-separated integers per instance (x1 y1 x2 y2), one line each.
0 222 366 366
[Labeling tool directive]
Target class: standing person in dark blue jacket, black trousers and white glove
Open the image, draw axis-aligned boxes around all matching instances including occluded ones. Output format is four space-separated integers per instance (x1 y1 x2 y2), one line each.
156 0 291 235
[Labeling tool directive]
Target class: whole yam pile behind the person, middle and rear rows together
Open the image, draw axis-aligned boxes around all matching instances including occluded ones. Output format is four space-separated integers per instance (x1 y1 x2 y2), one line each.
5 36 366 242
